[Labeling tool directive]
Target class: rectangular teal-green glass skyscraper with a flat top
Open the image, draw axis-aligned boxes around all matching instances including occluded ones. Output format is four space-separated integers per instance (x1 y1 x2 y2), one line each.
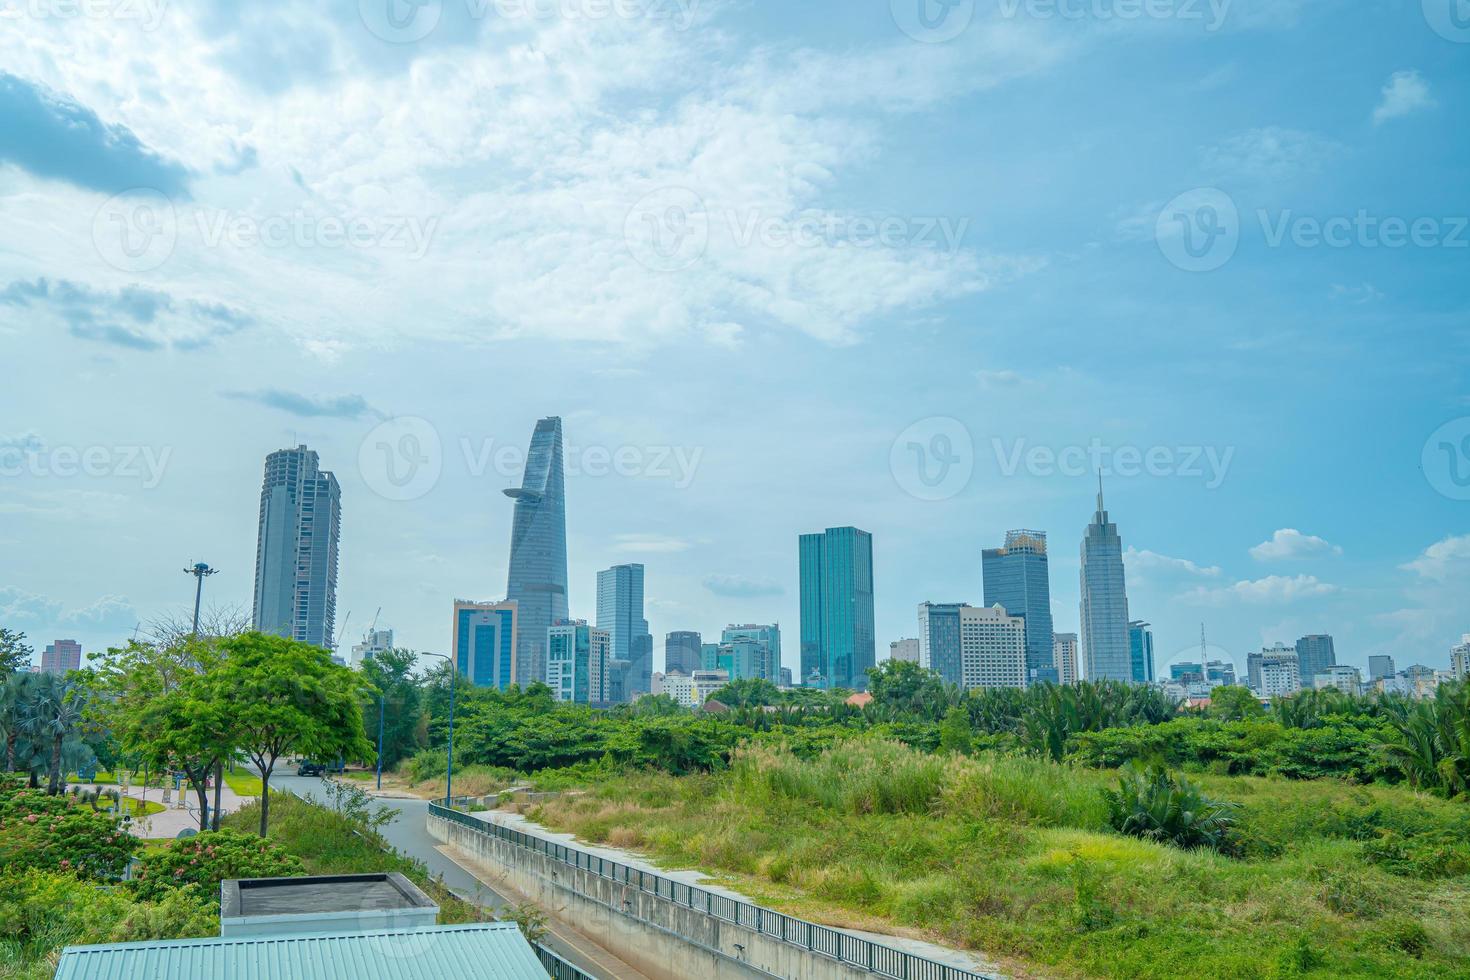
800 527 878 691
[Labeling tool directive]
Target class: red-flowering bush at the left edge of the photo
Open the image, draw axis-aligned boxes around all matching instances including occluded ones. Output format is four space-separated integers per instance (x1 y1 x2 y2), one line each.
0 783 138 880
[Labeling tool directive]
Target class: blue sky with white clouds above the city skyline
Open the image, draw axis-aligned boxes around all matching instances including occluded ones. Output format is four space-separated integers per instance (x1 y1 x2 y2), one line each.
0 0 1470 678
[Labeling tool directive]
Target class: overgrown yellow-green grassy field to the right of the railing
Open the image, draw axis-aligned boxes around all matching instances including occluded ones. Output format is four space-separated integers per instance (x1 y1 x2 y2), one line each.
531 742 1470 980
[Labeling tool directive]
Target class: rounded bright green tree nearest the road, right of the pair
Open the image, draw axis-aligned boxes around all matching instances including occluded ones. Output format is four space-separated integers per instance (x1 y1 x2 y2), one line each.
206 633 373 837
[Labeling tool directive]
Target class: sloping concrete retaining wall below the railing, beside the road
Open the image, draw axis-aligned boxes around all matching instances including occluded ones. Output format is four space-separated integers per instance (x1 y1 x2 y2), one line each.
428 813 893 980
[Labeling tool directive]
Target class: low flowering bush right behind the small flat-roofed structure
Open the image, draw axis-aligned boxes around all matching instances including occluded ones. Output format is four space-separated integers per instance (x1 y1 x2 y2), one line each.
134 830 304 898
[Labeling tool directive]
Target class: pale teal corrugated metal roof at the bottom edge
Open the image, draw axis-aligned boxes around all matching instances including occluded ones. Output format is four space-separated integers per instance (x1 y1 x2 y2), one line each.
56 923 547 980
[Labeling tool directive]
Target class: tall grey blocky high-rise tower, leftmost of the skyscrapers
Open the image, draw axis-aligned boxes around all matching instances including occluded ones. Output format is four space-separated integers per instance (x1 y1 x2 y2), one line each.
251 445 343 649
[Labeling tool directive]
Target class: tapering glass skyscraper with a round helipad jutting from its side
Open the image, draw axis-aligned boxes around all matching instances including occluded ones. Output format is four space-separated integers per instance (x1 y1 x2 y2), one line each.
506 417 567 686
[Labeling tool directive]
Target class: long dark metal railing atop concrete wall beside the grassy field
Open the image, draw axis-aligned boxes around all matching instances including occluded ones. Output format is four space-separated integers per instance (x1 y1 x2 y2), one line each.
429 802 995 980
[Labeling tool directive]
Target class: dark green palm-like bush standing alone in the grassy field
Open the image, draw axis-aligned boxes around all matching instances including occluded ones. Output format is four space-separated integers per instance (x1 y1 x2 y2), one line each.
1103 763 1238 852
